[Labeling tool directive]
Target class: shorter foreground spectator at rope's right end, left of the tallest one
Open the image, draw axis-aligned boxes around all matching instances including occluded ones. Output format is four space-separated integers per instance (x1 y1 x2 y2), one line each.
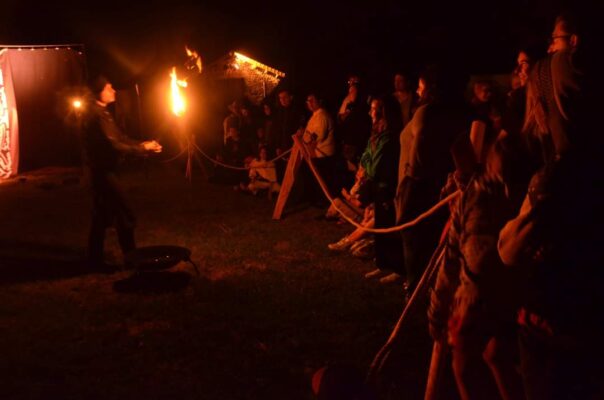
428 135 526 399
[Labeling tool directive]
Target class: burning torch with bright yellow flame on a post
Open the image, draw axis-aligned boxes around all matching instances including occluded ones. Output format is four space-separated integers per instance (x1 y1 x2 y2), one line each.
170 47 202 181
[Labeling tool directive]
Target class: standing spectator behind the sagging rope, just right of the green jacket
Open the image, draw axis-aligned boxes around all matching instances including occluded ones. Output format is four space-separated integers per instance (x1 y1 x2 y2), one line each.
396 67 470 289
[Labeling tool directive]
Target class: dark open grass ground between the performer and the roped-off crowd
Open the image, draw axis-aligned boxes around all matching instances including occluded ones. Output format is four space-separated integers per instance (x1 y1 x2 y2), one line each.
0 164 436 399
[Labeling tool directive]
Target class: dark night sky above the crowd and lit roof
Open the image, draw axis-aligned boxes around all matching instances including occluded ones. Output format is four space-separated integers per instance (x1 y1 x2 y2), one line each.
0 0 596 98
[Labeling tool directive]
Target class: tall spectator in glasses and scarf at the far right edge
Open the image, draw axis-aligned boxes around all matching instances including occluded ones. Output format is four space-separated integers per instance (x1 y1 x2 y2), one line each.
498 10 604 399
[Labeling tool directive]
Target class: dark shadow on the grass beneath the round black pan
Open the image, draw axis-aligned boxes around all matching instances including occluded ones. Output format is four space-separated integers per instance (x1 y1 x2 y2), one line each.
113 271 191 295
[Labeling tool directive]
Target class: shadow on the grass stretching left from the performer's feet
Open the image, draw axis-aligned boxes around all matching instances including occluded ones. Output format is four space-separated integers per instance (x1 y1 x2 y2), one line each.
0 240 92 285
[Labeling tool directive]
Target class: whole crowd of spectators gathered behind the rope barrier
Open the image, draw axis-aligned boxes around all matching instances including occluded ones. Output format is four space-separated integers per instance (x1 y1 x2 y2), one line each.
210 11 604 399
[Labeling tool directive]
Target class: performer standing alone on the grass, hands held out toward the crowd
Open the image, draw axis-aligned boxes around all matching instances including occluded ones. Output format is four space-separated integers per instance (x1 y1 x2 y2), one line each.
82 76 162 268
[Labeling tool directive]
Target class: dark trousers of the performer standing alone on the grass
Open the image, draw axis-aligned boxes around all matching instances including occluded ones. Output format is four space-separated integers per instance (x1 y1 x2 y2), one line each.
88 172 136 262
